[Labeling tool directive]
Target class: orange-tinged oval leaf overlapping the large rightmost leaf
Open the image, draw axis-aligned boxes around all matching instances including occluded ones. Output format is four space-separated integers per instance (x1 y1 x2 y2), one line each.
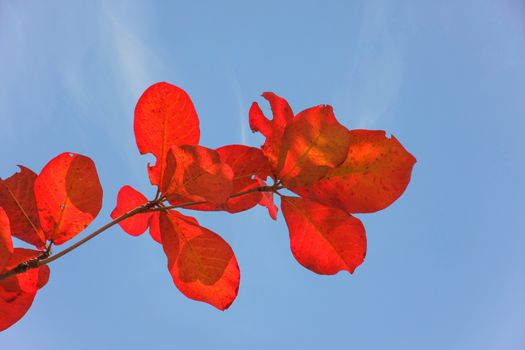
277 106 350 187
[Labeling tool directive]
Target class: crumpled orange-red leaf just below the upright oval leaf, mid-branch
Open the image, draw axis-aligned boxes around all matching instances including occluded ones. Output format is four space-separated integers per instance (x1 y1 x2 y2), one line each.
161 145 233 204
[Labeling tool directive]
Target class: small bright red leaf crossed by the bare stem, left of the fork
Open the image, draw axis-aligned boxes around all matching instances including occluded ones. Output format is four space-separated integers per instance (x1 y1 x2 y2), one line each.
111 185 152 236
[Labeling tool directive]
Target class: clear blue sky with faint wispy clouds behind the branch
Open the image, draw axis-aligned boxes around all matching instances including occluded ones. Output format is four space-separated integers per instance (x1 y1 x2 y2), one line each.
0 0 525 350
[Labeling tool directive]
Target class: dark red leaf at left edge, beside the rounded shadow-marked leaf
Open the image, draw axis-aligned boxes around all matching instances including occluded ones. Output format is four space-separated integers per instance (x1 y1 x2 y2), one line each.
0 166 45 248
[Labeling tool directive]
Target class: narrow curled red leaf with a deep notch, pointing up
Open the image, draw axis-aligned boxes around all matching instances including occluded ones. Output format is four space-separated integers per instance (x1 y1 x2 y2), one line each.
250 92 293 171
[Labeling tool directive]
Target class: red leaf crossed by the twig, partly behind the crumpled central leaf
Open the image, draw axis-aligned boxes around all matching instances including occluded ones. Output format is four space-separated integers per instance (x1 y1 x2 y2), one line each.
188 145 270 213
